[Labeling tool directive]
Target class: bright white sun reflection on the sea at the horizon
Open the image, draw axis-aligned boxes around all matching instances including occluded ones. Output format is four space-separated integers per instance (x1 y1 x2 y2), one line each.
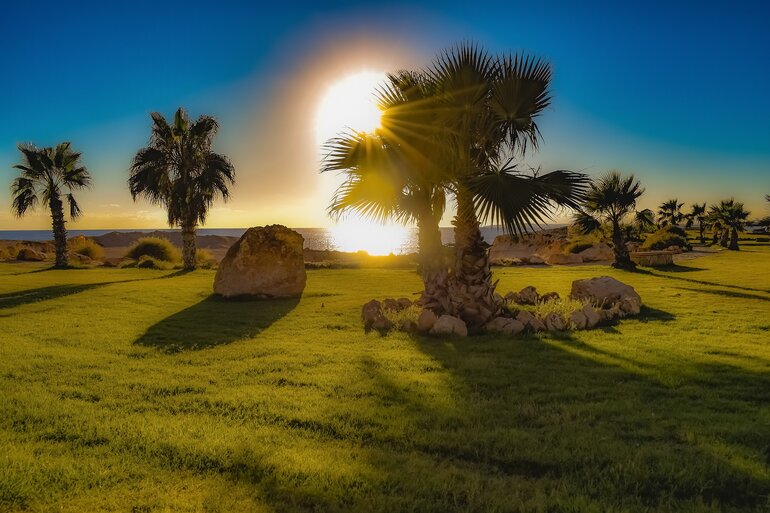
330 219 411 255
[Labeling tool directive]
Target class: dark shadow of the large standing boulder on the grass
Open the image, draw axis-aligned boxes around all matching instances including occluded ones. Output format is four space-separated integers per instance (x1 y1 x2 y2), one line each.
134 294 299 353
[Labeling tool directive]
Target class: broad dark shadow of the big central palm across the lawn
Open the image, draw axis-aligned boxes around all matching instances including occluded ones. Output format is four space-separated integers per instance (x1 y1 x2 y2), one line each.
402 334 770 511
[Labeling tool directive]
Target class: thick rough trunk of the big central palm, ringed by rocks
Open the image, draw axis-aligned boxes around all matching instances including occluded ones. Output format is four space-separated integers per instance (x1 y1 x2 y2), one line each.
449 188 503 329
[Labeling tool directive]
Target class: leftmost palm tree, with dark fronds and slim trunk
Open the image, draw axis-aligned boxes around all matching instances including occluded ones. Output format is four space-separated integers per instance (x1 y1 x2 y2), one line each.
11 142 91 269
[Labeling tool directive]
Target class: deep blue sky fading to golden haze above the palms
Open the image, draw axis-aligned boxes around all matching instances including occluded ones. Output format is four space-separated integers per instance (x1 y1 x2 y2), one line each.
0 0 770 229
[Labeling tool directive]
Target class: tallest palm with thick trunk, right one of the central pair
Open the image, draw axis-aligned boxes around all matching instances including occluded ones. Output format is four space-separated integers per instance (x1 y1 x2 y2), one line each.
426 44 588 326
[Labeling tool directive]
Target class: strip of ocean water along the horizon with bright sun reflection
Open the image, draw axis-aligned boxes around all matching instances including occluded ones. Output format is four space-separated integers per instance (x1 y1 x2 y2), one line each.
0 225 552 255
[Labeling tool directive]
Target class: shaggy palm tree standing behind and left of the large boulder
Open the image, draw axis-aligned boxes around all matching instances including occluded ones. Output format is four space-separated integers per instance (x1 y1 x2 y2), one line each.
128 108 235 270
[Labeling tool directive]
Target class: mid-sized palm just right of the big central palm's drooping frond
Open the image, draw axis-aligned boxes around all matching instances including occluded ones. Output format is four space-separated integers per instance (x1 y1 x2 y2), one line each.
574 171 649 270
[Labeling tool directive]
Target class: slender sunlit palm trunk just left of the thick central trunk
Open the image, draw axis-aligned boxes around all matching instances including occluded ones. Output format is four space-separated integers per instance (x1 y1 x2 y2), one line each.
417 213 451 313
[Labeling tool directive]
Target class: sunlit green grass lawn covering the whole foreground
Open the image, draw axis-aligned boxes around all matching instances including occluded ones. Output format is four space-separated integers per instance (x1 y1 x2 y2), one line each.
0 244 770 513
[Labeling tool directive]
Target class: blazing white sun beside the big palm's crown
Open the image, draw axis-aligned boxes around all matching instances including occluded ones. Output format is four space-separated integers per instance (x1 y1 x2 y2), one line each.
315 71 386 144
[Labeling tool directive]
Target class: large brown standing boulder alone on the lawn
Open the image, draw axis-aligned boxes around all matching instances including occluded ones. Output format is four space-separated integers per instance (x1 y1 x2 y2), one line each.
214 224 307 298
